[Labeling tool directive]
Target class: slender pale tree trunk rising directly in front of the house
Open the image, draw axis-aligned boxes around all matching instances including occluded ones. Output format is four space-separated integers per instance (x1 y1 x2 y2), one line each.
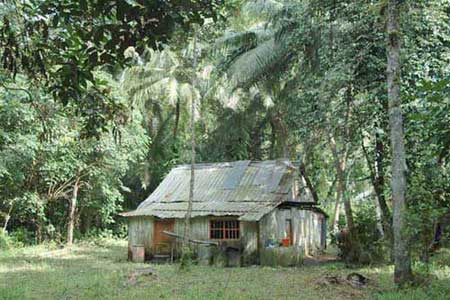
183 30 197 249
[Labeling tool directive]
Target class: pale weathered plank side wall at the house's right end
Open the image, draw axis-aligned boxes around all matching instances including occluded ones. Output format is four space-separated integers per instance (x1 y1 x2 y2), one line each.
260 207 324 254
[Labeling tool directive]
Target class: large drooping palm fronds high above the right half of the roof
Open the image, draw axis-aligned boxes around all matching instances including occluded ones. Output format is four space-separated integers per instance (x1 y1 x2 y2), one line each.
216 0 298 89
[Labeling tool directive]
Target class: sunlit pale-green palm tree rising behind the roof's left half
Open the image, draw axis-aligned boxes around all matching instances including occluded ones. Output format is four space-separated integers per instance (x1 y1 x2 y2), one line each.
120 48 199 191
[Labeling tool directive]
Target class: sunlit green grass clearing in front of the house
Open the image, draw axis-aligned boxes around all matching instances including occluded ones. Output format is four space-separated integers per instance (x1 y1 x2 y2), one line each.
0 239 450 299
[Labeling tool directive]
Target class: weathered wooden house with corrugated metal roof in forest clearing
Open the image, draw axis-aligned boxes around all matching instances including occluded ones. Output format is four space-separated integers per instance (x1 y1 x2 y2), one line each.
121 160 326 263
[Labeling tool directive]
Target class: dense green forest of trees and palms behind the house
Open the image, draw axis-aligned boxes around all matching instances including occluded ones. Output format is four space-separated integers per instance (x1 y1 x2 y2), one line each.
0 0 450 286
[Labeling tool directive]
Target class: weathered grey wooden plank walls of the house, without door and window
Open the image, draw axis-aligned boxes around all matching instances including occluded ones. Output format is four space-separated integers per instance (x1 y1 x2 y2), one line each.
128 207 325 264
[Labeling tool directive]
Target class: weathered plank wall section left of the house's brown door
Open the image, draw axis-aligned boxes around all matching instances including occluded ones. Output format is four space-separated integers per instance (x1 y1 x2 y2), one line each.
128 217 153 259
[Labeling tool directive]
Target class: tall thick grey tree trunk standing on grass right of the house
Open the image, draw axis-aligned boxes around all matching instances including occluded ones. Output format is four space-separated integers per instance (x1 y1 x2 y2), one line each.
387 0 412 285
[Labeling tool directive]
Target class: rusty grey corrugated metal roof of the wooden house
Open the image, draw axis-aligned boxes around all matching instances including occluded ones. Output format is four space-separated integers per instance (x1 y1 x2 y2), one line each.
122 160 293 220
